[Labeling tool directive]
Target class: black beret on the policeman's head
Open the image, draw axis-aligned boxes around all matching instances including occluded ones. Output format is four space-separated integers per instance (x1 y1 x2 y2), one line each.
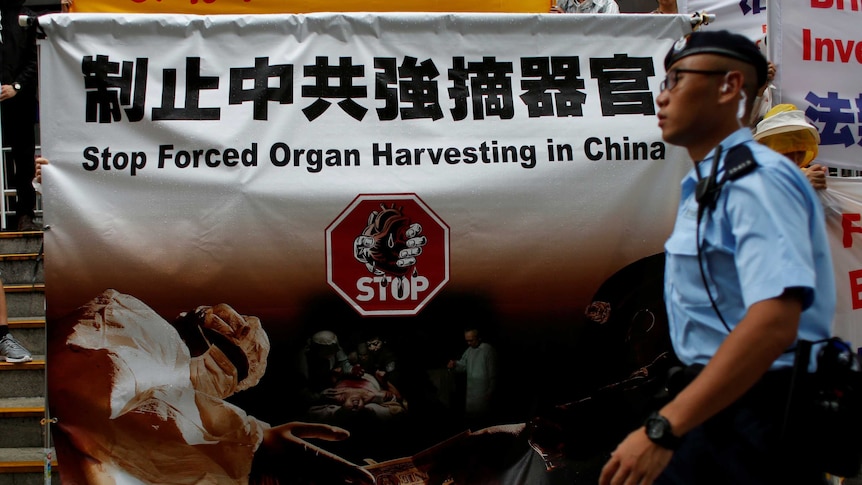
664 30 768 87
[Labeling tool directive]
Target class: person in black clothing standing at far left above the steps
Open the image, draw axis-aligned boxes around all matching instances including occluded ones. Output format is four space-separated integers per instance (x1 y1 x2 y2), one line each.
0 0 40 231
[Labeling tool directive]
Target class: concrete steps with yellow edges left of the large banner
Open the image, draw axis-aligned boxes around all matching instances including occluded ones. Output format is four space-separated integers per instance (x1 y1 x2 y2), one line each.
0 232 60 485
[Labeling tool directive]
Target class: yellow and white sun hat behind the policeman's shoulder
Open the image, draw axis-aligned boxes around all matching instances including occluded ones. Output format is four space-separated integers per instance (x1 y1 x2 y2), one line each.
754 104 820 167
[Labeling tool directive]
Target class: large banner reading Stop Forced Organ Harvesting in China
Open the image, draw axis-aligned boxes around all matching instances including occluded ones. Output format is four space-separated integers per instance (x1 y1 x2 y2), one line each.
41 14 691 484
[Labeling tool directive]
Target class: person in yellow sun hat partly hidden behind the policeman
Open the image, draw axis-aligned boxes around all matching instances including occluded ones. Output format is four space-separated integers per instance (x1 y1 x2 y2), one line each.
754 104 826 190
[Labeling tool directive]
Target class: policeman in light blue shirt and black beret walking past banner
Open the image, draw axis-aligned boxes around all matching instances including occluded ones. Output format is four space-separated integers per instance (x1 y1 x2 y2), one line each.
600 31 835 485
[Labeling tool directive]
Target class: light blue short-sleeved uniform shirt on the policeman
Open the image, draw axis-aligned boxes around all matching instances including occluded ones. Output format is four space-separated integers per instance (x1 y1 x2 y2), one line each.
664 128 836 369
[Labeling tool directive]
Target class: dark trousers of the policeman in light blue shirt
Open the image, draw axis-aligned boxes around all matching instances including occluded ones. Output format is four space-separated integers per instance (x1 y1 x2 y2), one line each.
656 371 825 485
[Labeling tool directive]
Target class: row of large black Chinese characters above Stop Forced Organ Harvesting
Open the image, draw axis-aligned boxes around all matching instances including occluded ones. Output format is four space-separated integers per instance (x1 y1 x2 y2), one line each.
81 53 656 123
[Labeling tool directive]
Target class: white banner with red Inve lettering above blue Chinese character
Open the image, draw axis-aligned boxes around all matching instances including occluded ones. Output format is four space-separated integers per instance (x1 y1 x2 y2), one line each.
769 0 862 170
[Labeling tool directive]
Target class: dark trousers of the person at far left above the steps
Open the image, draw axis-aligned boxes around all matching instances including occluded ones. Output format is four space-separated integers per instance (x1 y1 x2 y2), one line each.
0 94 37 217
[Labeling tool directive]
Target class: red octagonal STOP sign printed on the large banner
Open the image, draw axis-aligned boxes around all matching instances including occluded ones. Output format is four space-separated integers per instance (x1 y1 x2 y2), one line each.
326 194 449 316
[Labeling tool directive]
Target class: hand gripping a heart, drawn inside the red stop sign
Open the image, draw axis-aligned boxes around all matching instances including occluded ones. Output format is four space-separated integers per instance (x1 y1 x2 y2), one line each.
353 204 428 276
